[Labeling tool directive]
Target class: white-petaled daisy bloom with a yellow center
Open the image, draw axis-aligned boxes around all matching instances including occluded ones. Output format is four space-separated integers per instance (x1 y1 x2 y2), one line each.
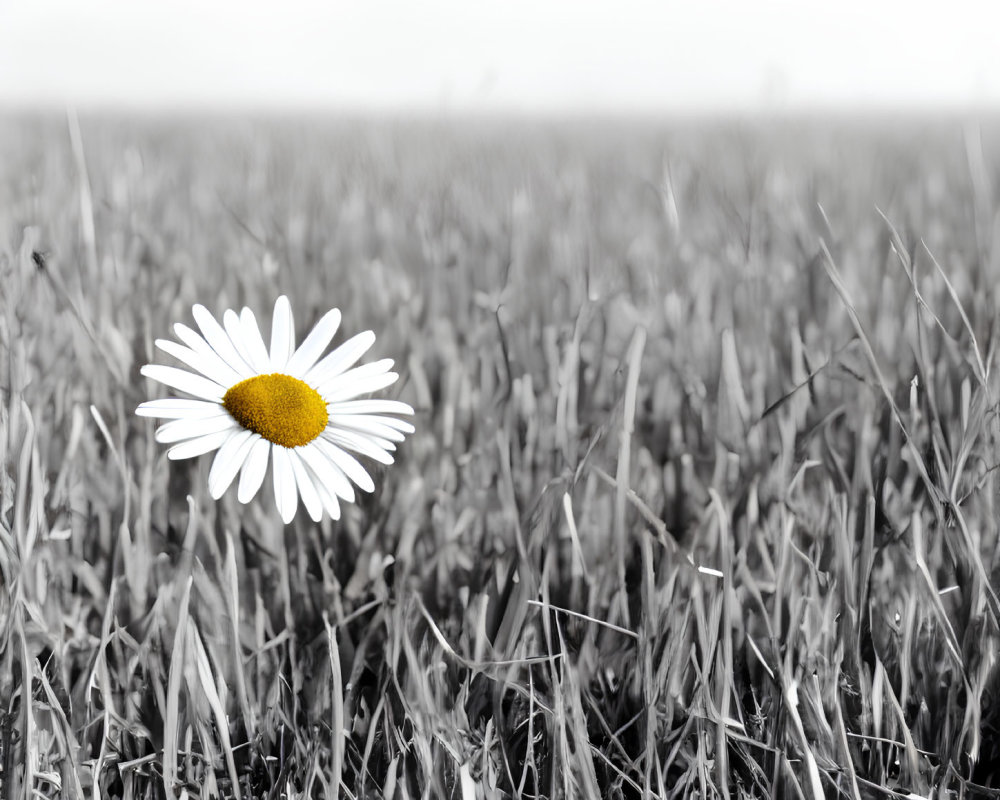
135 296 414 523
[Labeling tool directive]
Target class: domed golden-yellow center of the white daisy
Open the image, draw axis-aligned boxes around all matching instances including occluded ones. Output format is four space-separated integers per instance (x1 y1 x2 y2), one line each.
222 372 330 447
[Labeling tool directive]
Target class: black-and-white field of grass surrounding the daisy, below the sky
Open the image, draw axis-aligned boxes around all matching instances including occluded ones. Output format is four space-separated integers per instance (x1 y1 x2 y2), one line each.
0 117 1000 800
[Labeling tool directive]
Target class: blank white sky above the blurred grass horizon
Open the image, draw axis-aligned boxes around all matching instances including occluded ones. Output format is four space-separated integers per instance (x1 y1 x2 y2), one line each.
0 0 1000 113
